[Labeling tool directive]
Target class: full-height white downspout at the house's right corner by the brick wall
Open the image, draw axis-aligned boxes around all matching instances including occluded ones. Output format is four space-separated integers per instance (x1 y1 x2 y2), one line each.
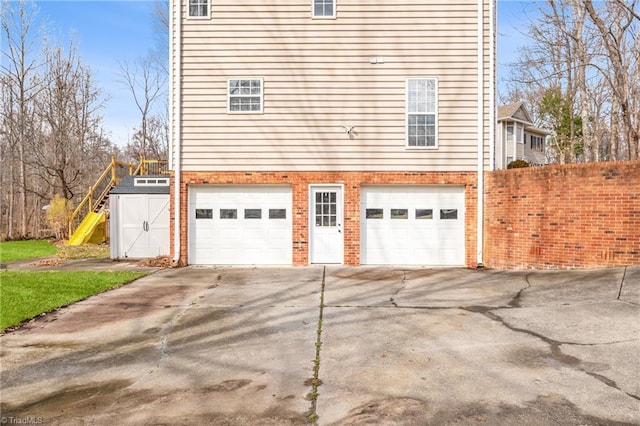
476 0 484 266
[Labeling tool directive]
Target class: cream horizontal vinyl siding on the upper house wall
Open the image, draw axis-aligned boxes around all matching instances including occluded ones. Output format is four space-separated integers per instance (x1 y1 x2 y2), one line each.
172 0 491 172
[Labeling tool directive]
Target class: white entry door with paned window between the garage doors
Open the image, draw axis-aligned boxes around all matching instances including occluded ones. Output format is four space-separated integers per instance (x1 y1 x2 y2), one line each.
309 185 344 263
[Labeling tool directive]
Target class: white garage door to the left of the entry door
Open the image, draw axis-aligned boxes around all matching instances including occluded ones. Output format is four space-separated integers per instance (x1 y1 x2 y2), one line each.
189 186 293 265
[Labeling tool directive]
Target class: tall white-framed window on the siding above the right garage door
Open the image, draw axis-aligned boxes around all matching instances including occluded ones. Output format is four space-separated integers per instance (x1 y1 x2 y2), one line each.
407 78 438 148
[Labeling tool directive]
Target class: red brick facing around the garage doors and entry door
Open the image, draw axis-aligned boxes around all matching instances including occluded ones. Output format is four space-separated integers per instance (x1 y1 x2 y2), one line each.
169 172 477 267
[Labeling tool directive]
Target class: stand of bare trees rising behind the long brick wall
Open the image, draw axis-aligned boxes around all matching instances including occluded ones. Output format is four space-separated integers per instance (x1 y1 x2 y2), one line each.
511 0 640 162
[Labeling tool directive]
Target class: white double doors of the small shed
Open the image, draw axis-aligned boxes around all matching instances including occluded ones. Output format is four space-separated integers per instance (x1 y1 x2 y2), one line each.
117 194 169 258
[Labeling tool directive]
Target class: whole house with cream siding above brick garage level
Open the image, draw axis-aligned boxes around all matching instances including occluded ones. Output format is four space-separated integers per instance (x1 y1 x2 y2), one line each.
170 0 495 266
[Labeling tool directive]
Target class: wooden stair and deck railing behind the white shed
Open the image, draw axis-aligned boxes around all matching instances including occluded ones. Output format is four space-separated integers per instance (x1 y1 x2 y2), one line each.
69 157 169 237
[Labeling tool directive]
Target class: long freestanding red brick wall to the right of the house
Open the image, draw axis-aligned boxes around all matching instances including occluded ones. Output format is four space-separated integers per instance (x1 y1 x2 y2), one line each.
484 161 640 269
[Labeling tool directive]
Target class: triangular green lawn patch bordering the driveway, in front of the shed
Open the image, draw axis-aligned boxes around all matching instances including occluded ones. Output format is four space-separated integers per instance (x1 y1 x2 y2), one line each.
0 271 147 330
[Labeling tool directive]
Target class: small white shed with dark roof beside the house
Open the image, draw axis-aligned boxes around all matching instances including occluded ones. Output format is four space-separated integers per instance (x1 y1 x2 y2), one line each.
109 175 169 259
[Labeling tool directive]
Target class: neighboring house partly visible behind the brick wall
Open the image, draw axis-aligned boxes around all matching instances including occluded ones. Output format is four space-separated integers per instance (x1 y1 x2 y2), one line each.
495 102 550 169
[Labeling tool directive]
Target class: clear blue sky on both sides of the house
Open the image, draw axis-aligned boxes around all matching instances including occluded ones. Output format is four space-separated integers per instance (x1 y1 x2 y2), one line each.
21 0 539 146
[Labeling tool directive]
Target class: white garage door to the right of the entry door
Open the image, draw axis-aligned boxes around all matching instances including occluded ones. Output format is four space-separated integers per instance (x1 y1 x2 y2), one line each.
360 186 465 266
